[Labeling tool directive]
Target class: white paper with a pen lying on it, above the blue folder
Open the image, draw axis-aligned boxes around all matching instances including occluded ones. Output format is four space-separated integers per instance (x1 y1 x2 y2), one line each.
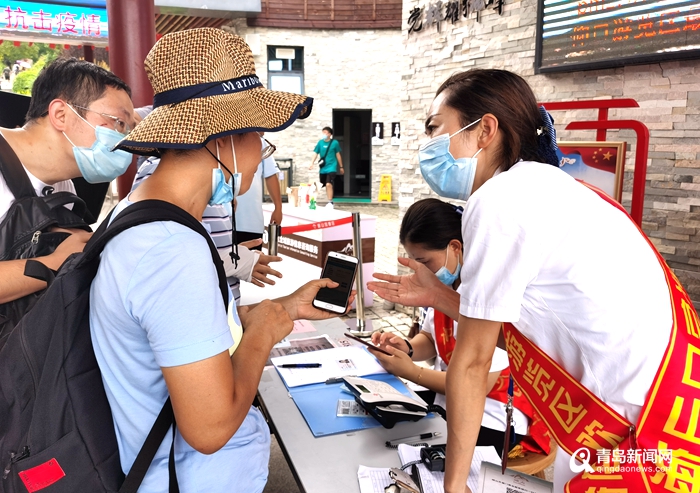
272 346 386 388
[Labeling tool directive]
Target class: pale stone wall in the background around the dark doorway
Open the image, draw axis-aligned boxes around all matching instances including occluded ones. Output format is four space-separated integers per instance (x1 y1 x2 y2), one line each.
225 19 405 201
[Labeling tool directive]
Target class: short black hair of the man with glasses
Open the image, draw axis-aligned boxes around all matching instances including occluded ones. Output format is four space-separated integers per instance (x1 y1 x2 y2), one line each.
26 58 131 122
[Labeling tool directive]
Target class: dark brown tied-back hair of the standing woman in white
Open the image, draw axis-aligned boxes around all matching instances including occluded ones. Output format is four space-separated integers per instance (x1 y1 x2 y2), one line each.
436 69 547 171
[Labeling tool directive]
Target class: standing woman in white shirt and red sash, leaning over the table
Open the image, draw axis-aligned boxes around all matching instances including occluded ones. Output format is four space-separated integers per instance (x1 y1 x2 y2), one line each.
372 70 700 493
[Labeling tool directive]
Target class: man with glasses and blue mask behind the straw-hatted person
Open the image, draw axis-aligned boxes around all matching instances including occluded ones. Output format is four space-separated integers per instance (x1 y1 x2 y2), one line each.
0 58 134 304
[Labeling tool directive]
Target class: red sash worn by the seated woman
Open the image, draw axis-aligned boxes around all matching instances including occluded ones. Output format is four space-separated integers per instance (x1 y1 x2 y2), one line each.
434 310 552 454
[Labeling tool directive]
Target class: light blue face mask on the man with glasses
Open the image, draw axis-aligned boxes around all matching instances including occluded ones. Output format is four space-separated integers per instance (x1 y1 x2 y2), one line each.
63 105 133 183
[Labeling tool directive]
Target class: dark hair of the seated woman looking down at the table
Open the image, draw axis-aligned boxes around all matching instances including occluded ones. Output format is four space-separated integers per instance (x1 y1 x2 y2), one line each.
399 198 462 250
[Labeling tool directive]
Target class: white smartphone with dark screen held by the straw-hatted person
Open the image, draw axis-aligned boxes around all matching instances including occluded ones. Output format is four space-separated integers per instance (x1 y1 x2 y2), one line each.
313 252 357 313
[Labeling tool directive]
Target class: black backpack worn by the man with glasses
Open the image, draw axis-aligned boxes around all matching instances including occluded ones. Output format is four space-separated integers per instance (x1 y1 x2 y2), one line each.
0 136 91 347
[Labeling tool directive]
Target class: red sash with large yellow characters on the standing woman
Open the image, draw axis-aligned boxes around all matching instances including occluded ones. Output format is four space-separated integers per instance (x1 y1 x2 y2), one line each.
503 185 700 493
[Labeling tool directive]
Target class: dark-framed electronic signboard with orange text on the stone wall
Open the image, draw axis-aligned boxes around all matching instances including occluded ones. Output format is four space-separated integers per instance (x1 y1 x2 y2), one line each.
535 0 700 73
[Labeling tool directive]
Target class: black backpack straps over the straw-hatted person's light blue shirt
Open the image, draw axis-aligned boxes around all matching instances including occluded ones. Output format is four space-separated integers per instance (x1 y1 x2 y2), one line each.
82 200 229 493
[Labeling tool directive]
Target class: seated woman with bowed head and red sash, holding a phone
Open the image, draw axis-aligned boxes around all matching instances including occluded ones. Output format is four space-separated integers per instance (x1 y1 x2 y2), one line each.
372 198 550 455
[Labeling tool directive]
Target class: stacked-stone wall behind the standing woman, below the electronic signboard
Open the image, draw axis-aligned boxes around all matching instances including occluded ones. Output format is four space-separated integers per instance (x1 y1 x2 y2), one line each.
399 0 700 308
